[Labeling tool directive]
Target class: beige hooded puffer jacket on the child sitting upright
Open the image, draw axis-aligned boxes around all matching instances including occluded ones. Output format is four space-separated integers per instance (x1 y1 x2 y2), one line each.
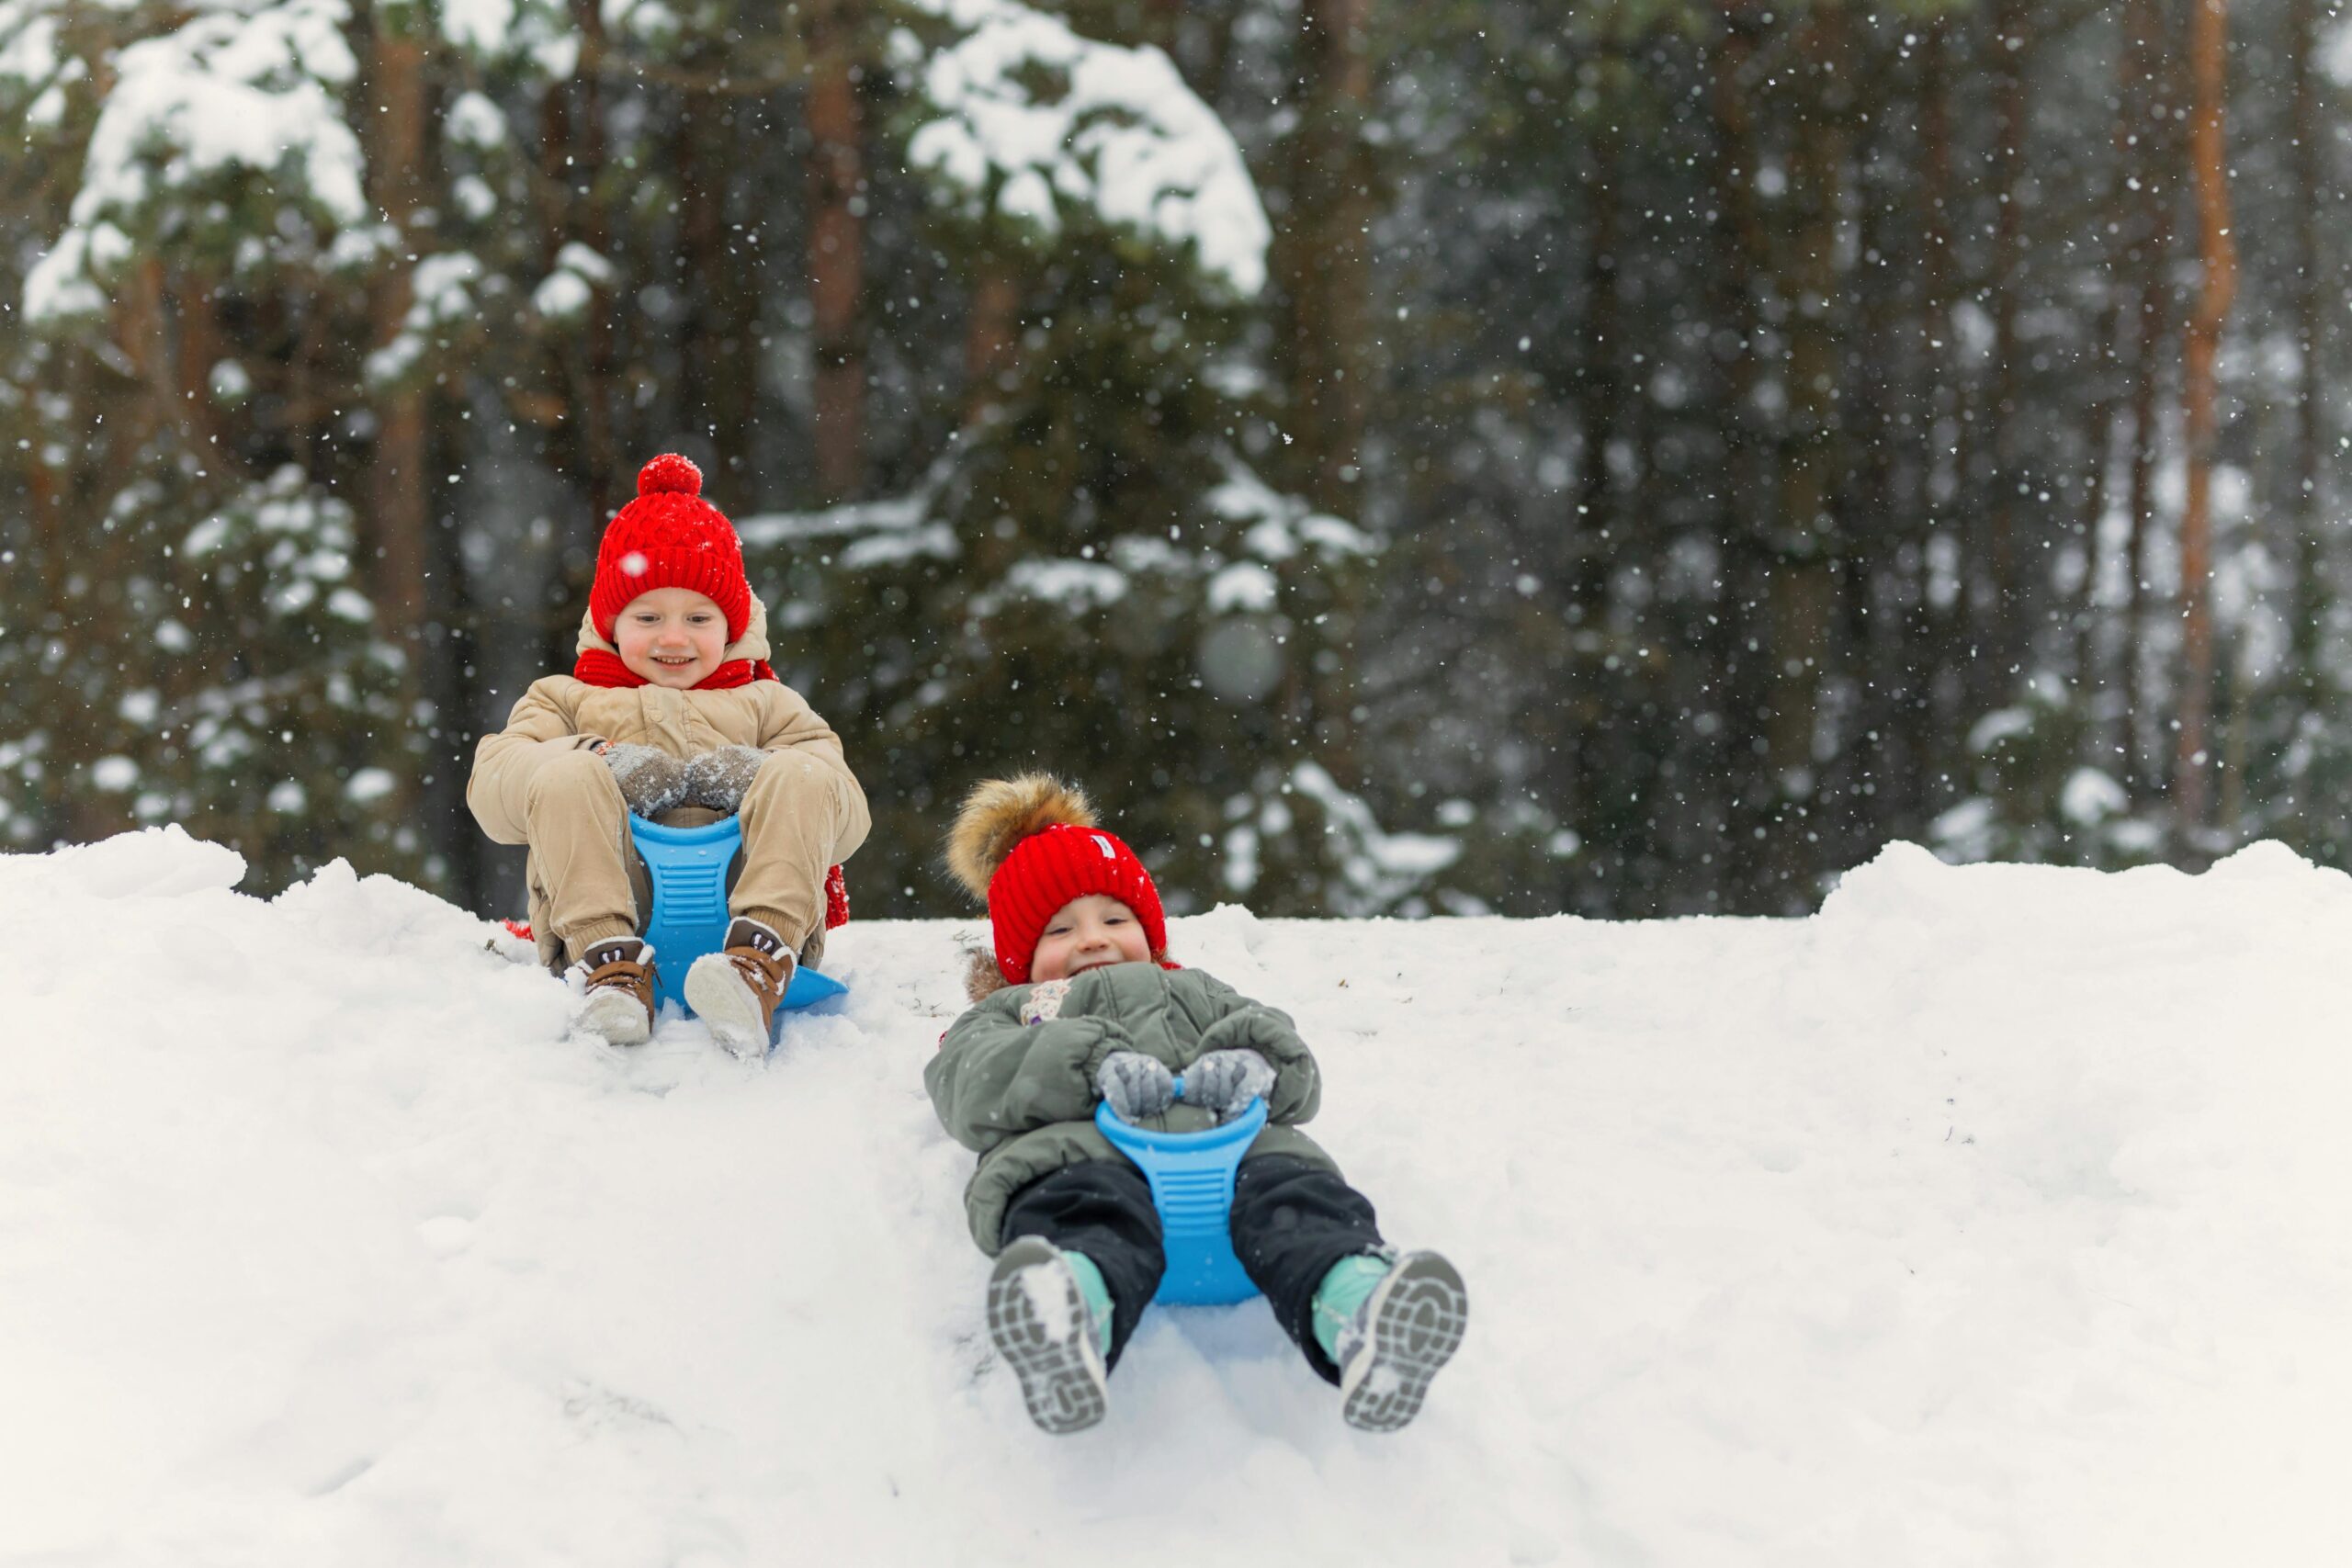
466 594 873 964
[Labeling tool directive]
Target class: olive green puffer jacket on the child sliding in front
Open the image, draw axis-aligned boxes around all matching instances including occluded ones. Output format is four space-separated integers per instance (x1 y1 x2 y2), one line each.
922 964 1339 1256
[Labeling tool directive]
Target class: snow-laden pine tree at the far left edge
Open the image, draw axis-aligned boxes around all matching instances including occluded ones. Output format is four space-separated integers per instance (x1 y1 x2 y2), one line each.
0 0 428 886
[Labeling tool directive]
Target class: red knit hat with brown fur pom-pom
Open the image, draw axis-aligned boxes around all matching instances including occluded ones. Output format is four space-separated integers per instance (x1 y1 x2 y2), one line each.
948 773 1169 985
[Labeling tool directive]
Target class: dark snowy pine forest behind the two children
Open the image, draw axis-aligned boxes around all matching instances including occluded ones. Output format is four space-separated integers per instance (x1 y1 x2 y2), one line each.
0 0 2352 917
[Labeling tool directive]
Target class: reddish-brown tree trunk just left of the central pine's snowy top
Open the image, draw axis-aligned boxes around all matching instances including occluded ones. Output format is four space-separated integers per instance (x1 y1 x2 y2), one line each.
802 0 865 501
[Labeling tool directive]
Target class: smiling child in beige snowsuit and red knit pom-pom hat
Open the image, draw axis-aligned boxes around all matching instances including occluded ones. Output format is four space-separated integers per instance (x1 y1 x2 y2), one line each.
466 454 870 1054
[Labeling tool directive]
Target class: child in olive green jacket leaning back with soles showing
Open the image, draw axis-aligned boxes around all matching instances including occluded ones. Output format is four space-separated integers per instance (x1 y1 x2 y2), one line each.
924 773 1470 1432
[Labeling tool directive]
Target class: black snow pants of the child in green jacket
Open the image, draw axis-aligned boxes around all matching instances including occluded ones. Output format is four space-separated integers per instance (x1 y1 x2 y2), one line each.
1004 1155 1381 1382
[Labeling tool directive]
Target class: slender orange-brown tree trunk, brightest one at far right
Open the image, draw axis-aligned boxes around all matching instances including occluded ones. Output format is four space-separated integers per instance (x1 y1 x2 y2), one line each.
2173 0 2237 840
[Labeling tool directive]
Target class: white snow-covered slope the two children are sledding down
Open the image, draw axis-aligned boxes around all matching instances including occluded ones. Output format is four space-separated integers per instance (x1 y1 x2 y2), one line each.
0 829 2352 1568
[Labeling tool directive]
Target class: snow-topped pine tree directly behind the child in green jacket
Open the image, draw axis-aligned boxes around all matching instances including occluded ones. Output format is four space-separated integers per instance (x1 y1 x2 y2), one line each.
746 5 1452 912
